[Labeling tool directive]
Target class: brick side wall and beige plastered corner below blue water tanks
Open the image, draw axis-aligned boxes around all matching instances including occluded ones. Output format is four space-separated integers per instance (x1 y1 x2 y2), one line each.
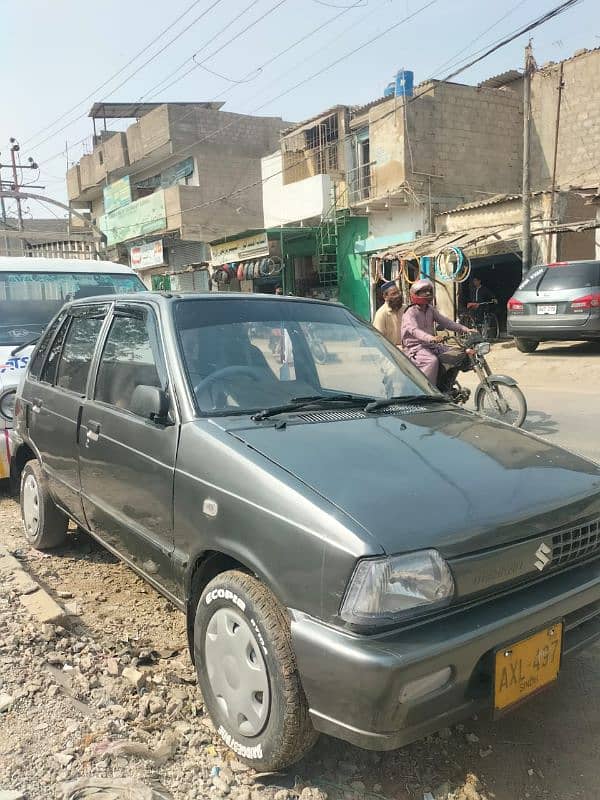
364 83 523 210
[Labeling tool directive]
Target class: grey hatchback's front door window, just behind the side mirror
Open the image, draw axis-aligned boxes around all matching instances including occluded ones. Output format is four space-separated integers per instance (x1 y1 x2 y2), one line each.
94 312 167 411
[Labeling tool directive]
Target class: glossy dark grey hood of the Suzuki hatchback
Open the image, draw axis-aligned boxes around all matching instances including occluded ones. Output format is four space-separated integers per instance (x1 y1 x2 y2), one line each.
227 409 600 558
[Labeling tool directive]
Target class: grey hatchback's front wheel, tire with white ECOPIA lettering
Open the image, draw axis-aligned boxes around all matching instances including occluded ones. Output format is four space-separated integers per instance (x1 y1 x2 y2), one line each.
194 570 317 770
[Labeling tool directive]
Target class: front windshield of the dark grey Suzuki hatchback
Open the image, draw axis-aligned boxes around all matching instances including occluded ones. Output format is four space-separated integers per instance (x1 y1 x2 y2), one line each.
175 298 432 414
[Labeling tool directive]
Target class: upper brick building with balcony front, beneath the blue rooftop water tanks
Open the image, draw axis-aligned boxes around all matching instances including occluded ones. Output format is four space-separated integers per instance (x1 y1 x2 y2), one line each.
349 71 522 251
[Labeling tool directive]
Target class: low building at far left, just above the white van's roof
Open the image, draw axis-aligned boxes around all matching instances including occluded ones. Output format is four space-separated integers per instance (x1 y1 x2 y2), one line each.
0 219 96 260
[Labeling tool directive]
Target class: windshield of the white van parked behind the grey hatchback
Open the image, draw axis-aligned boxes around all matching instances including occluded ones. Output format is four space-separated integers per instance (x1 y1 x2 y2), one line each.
0 271 145 347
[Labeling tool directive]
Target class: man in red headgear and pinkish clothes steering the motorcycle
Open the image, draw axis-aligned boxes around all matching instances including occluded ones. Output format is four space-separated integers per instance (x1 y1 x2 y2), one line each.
401 278 473 386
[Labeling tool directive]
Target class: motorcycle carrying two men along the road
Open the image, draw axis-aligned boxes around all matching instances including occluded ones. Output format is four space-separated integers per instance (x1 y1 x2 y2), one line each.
437 334 527 428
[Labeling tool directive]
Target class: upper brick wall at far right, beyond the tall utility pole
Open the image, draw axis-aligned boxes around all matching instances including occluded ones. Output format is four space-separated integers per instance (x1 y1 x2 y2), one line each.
531 50 600 189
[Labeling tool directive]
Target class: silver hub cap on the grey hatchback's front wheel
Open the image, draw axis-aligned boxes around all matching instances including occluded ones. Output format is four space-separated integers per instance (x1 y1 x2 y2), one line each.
205 608 271 737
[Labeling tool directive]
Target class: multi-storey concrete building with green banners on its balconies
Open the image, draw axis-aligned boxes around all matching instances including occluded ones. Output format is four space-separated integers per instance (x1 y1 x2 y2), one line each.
67 102 285 286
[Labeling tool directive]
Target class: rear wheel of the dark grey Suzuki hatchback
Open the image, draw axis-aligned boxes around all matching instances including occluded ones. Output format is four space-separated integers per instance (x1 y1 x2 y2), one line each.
20 460 69 550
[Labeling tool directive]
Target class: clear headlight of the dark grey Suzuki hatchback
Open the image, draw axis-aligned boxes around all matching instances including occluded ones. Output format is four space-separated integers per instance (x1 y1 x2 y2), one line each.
340 550 454 625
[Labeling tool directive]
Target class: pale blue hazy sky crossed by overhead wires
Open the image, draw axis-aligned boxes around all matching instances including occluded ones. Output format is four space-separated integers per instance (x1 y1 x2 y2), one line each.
0 0 600 217
